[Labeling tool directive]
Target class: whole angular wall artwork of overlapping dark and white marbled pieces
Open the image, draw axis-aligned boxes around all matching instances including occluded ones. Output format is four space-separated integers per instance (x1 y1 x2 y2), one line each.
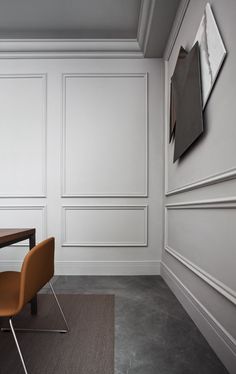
169 3 226 162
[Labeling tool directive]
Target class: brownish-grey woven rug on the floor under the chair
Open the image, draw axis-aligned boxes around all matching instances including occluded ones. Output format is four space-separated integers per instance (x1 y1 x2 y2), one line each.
0 294 114 374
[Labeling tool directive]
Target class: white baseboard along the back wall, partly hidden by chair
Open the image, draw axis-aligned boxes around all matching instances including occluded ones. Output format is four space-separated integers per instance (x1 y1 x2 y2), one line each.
0 261 160 275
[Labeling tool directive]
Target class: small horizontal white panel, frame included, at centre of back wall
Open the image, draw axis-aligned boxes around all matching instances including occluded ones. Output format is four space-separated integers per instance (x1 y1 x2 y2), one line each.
62 206 147 247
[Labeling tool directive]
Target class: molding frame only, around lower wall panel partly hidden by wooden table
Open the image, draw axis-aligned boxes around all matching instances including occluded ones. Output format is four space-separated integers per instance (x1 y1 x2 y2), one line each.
0 205 47 247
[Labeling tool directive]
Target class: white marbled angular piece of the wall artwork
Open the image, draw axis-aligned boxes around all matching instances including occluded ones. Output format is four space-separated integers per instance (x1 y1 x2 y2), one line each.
194 3 226 107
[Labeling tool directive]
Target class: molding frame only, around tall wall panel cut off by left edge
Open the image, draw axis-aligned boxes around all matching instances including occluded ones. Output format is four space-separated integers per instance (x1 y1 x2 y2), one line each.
0 73 47 198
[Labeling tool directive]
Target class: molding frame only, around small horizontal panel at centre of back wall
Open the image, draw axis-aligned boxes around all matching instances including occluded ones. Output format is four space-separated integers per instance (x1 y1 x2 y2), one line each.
62 205 148 247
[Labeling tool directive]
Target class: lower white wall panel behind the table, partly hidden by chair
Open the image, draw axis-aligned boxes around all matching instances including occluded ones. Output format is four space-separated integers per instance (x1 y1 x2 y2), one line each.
0 206 46 246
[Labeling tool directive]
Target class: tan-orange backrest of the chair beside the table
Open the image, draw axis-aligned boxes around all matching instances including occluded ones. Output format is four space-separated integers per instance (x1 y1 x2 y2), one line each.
19 238 55 309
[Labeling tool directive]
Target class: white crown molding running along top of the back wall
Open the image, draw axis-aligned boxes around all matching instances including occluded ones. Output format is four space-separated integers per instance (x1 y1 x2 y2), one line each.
0 39 144 59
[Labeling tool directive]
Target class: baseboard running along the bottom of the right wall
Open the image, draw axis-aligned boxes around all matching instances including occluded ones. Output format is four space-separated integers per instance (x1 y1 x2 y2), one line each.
160 262 236 374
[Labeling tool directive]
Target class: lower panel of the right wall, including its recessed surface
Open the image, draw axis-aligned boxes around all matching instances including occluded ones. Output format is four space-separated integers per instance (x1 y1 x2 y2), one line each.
165 204 236 298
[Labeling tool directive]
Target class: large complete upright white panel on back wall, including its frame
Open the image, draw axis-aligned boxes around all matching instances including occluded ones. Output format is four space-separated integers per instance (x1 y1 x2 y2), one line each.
62 74 148 196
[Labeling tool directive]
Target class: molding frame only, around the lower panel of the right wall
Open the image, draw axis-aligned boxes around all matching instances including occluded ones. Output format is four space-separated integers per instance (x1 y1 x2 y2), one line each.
164 197 236 305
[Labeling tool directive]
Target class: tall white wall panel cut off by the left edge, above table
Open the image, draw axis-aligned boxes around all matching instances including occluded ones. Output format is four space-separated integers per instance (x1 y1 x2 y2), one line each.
0 75 46 197
